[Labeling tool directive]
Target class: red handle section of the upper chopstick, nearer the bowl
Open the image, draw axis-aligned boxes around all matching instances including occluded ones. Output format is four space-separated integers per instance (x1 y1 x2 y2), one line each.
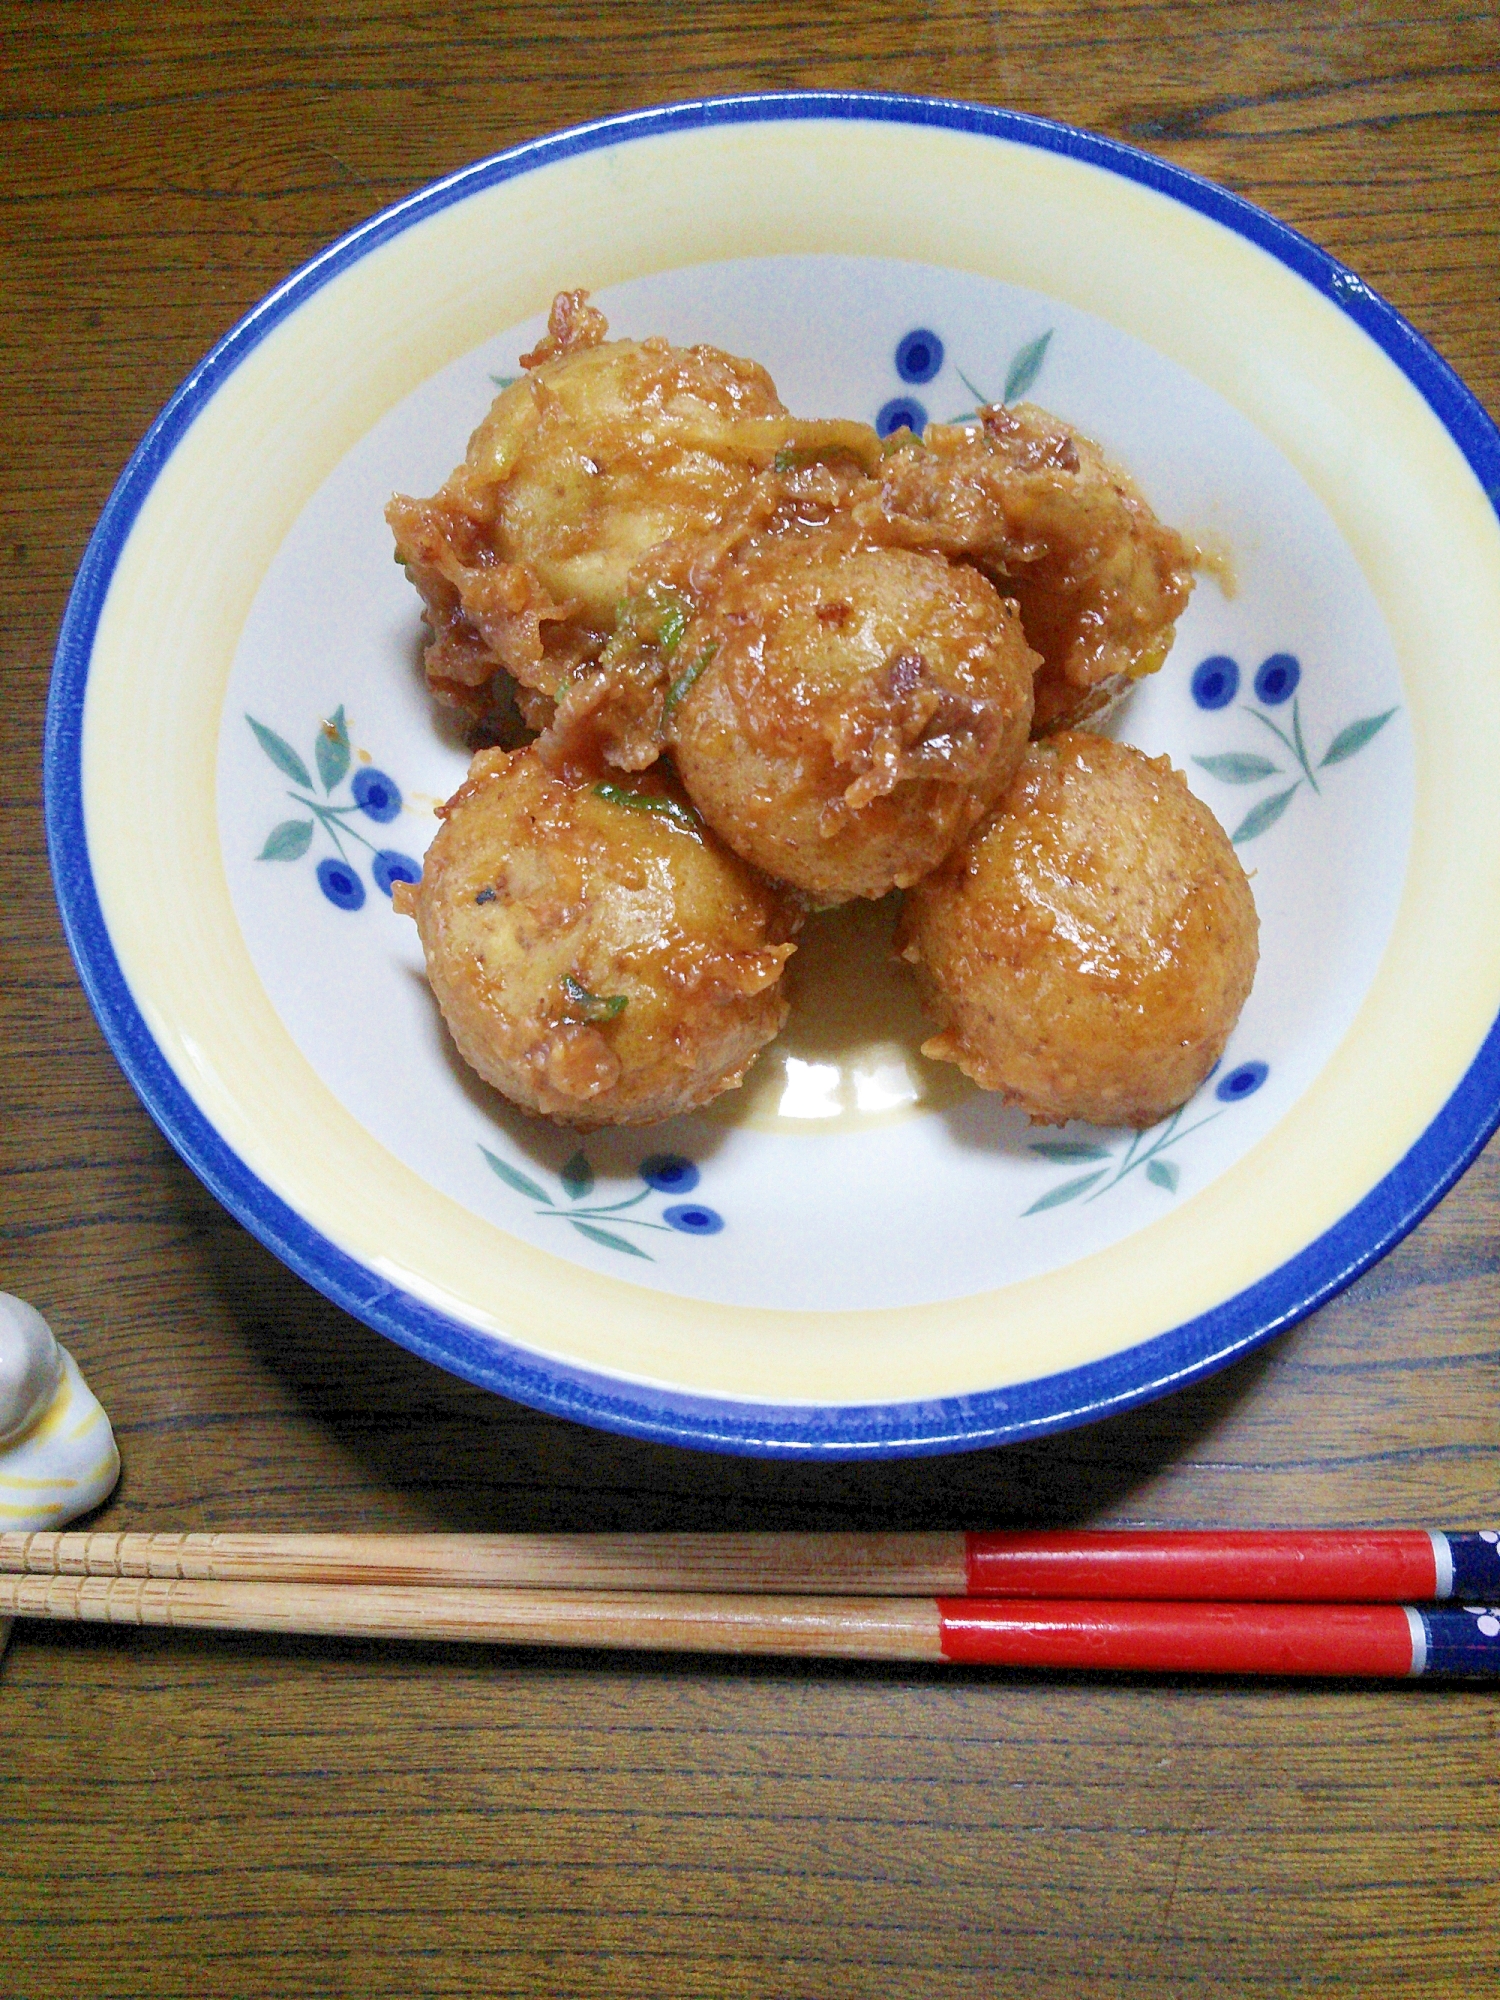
964 1528 1448 1604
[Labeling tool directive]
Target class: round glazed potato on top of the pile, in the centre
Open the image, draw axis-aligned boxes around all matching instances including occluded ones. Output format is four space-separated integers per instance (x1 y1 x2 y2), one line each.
666 522 1036 904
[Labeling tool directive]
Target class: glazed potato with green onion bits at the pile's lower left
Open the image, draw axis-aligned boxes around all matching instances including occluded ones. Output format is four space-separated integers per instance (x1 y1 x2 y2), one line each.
396 748 796 1128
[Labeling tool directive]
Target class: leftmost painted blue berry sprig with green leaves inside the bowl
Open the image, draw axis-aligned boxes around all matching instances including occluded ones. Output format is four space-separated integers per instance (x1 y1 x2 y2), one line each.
244 702 422 912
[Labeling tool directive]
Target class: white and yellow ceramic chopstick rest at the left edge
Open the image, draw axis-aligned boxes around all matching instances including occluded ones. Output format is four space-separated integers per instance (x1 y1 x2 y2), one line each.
0 1292 120 1530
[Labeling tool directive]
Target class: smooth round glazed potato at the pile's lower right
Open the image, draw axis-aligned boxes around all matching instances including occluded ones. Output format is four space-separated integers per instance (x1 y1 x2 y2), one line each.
898 730 1258 1126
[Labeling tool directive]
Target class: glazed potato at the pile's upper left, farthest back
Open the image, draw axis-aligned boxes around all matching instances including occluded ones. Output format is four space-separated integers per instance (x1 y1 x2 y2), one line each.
386 292 786 712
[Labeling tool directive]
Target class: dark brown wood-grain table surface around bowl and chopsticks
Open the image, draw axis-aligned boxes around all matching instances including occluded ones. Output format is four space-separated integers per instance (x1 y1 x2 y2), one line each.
0 0 1500 2000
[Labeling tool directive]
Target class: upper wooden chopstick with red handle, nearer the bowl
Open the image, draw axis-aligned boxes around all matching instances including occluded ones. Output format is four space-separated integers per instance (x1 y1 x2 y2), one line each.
0 1528 1500 1604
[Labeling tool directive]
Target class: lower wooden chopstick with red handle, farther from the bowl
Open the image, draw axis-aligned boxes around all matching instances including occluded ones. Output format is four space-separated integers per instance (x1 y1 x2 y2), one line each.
0 1574 1500 1678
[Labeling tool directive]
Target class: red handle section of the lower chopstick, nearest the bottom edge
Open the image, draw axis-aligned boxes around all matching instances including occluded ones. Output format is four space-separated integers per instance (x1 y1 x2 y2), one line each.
938 1598 1424 1676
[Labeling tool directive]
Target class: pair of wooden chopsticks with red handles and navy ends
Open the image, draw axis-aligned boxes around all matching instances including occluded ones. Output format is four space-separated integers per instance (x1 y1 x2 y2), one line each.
0 1530 1500 1676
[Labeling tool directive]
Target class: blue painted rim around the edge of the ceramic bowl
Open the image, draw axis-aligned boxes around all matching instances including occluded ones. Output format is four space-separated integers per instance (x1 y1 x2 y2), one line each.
44 92 1500 1460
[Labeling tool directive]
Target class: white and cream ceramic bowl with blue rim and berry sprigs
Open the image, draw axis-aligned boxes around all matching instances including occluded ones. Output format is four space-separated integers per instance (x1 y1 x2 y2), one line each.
48 96 1500 1456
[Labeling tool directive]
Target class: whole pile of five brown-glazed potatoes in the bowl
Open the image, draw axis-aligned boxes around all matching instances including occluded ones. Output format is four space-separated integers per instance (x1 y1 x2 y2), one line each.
388 292 1256 1128
